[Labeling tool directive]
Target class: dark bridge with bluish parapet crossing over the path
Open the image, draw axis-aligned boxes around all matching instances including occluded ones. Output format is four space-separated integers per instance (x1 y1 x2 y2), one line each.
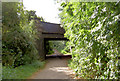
36 20 68 60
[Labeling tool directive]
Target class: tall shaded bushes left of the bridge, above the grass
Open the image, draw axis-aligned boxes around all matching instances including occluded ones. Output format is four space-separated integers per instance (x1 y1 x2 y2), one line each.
2 2 43 67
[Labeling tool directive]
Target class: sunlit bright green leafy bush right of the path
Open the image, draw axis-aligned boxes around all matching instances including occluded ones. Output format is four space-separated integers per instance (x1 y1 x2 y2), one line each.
60 2 120 79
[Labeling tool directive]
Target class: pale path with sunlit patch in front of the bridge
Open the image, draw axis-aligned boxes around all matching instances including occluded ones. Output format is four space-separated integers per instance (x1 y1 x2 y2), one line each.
29 57 73 79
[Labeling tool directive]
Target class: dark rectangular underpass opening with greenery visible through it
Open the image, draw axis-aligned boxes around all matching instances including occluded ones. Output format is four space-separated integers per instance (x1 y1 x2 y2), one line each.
44 38 71 59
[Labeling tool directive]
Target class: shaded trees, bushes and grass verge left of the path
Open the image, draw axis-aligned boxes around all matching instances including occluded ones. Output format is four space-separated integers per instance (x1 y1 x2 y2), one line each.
2 2 44 79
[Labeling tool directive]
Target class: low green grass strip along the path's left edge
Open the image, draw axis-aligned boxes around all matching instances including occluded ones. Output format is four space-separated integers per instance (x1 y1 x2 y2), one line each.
2 61 45 79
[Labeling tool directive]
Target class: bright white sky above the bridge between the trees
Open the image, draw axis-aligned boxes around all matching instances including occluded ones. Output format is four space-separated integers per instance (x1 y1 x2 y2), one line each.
23 0 60 24
